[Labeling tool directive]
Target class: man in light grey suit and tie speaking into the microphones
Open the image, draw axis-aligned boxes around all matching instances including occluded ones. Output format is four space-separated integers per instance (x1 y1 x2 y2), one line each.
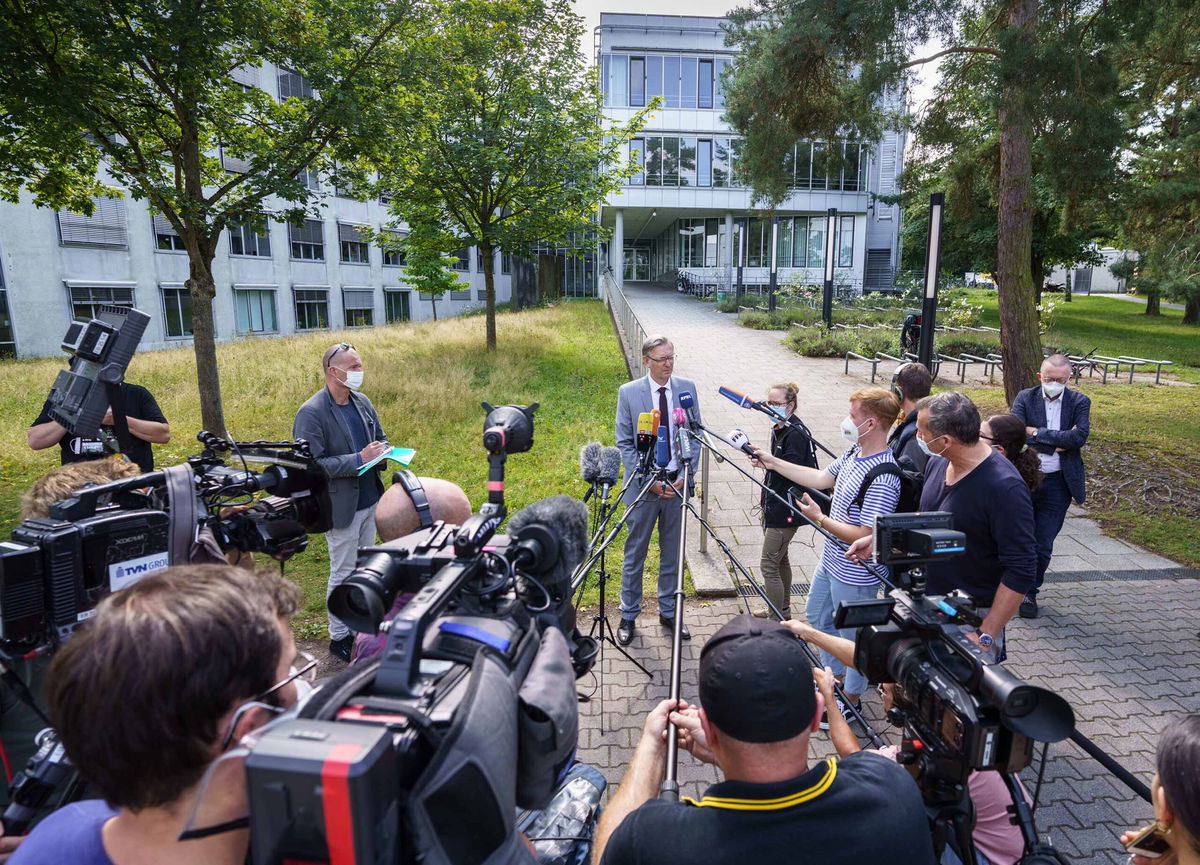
617 336 700 645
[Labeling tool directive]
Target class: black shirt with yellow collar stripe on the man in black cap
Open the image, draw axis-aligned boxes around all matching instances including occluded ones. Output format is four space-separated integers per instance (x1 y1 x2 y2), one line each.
602 751 935 865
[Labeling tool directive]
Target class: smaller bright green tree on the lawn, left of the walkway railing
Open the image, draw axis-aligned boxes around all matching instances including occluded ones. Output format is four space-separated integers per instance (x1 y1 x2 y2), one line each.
380 0 646 350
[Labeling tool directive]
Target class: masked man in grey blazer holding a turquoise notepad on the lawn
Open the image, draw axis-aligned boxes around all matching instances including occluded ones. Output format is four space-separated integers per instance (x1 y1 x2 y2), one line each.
292 342 389 661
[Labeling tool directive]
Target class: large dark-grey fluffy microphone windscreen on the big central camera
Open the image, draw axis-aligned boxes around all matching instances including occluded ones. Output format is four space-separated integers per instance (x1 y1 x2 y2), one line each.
508 495 588 603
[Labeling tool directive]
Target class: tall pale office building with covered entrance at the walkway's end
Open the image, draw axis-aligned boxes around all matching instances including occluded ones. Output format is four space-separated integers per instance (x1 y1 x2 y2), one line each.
596 13 905 290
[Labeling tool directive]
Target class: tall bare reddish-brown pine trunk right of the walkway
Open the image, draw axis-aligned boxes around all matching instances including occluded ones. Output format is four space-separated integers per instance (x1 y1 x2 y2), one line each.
996 0 1042 403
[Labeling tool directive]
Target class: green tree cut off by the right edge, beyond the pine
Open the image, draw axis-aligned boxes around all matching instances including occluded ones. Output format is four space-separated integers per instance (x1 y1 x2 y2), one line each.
1112 0 1200 324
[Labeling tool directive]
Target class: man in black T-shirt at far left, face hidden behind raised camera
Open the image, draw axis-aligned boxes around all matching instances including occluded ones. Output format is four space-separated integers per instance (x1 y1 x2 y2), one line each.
25 382 170 471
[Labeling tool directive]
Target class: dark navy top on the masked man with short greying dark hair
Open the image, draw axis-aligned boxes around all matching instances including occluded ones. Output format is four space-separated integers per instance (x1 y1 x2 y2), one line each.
920 451 1038 599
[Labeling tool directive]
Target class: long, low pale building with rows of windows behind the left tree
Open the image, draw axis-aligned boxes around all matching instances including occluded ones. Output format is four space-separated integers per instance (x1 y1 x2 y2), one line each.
0 66 512 356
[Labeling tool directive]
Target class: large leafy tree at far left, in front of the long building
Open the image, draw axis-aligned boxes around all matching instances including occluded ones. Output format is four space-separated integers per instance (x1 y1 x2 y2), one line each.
0 0 419 431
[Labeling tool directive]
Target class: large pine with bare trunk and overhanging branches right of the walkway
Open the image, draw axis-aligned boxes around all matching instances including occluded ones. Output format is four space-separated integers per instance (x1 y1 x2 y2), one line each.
726 0 1138 400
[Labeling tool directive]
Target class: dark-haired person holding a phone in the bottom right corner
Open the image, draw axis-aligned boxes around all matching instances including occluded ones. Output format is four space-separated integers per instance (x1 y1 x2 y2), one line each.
1121 715 1200 865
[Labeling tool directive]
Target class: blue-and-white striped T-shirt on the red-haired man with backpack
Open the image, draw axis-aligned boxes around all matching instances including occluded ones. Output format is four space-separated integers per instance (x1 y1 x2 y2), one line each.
821 444 900 585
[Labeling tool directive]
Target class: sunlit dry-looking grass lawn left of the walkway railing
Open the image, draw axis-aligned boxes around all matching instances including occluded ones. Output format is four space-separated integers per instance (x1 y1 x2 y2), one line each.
0 301 658 637
